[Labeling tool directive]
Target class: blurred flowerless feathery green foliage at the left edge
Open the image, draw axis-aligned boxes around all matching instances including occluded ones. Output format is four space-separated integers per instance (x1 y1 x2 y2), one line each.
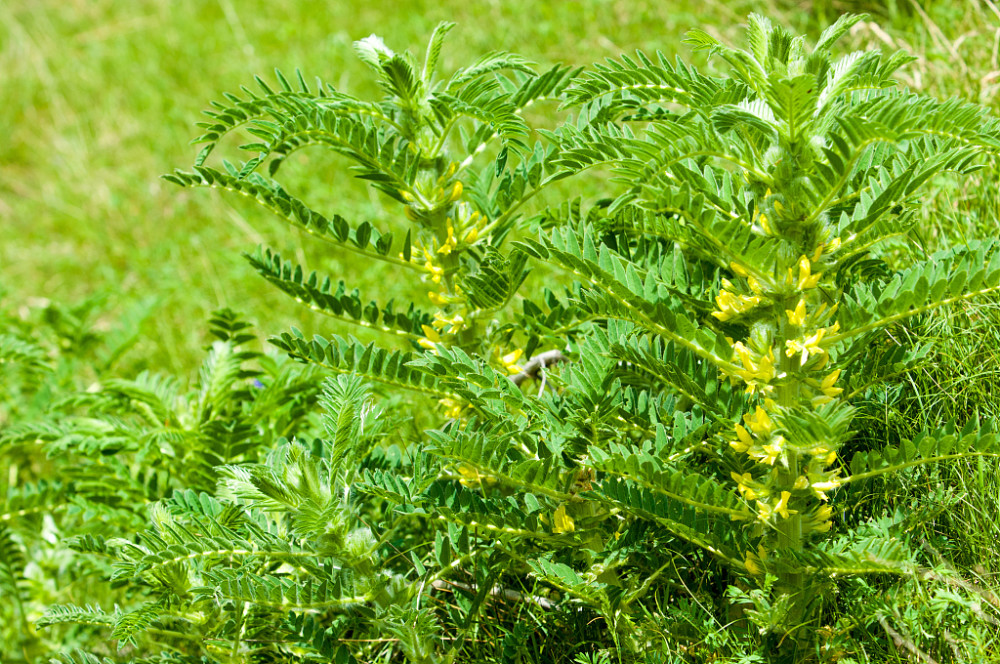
0 310 321 661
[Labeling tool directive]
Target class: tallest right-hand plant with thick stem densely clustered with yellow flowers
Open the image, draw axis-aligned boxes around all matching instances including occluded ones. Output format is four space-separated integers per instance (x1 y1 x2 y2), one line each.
523 15 1000 661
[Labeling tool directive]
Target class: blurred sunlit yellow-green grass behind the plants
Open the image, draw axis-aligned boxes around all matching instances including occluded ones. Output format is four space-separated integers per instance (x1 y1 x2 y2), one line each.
0 0 1000 373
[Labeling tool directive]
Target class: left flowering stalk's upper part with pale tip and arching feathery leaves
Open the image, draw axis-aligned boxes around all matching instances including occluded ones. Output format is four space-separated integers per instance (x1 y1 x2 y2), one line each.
165 23 573 370
